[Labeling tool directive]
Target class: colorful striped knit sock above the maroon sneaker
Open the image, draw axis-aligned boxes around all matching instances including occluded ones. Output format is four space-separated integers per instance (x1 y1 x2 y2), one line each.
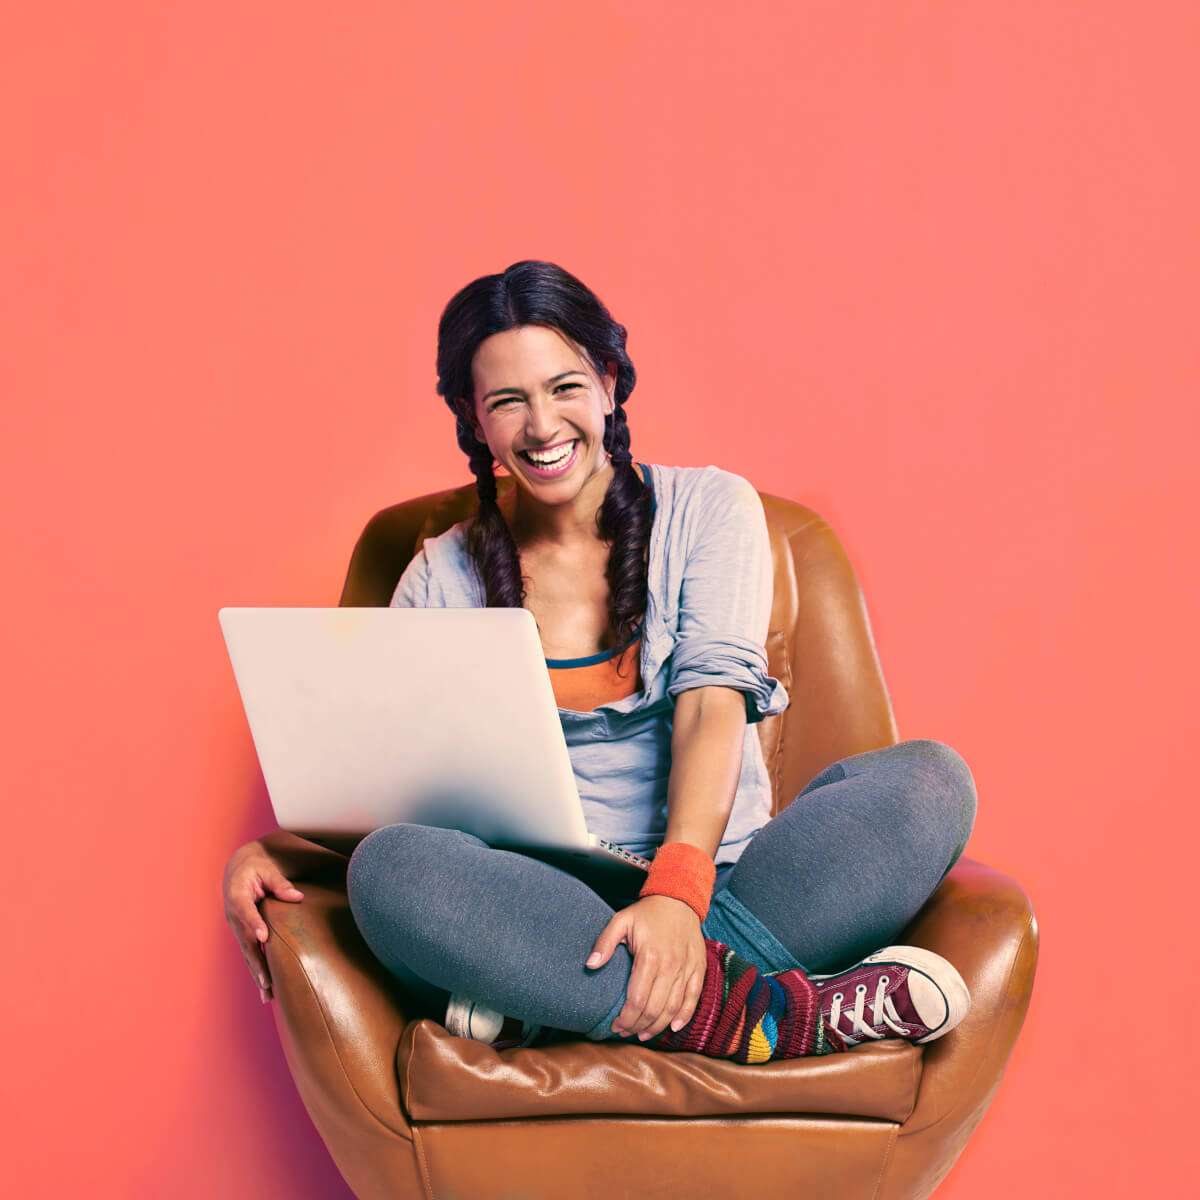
641 937 846 1063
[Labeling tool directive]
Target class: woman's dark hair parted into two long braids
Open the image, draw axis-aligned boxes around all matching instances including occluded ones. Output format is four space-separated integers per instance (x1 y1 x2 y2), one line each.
437 259 650 662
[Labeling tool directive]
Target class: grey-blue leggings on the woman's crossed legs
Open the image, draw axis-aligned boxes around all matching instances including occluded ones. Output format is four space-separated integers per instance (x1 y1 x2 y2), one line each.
347 738 976 1042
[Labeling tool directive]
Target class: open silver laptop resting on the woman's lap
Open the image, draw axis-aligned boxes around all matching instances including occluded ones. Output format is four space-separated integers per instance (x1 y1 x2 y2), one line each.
217 607 650 889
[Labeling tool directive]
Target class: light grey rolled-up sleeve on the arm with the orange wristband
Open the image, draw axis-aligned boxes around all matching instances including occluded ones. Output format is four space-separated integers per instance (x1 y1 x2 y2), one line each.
666 468 790 725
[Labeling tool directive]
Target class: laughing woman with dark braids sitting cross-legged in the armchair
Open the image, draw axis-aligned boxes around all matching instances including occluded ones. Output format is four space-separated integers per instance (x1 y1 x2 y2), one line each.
227 260 976 1062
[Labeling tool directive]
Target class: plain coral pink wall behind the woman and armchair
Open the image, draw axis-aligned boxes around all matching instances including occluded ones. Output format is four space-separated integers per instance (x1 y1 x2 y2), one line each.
0 0 1200 1200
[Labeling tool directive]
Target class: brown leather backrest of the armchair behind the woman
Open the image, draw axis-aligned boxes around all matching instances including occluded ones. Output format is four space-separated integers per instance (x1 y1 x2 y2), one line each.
338 475 898 816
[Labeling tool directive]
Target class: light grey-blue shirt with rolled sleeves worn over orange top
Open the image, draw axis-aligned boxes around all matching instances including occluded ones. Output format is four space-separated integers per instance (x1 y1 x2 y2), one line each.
391 464 790 866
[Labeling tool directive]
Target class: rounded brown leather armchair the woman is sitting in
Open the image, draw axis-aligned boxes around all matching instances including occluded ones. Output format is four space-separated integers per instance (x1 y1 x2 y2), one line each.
262 476 1038 1200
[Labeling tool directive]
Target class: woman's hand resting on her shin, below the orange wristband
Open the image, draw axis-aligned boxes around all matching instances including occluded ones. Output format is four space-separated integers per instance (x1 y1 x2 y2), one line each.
587 896 708 1042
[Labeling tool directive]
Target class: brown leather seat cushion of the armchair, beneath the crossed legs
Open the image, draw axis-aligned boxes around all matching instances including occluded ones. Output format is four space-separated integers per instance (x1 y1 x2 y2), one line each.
396 1018 924 1122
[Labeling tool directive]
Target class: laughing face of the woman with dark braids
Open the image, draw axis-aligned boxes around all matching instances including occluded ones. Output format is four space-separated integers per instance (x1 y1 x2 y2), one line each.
472 325 617 506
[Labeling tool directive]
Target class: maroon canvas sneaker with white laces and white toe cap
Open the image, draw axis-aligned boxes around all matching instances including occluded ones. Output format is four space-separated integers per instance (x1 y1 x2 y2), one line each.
809 946 971 1050
